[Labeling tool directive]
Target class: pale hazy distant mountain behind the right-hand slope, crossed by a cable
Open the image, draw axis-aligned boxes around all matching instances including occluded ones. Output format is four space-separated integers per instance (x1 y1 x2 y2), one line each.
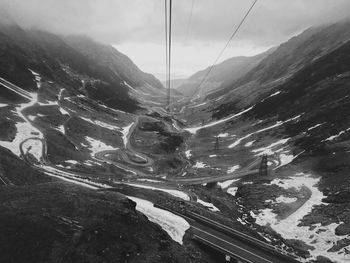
176 49 273 96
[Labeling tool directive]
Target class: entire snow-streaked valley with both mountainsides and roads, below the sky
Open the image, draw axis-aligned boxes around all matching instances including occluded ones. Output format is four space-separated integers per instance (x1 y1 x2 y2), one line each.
0 17 350 262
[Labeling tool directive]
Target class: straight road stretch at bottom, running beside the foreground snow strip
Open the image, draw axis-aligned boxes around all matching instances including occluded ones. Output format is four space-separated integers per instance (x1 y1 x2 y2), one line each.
154 204 299 263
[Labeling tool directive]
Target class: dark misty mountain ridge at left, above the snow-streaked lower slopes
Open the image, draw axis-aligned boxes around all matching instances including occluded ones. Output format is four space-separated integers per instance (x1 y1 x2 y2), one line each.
0 24 165 112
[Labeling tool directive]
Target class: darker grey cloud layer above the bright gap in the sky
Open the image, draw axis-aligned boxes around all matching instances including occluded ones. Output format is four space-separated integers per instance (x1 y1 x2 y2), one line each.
0 0 350 46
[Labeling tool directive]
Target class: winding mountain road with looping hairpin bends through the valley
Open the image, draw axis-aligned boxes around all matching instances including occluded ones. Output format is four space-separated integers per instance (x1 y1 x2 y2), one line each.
0 76 297 263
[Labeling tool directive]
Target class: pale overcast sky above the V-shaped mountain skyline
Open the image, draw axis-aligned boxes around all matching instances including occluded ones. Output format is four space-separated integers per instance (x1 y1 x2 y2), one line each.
0 0 350 79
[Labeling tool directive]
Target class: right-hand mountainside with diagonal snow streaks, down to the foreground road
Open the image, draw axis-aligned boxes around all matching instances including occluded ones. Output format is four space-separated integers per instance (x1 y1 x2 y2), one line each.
171 20 350 262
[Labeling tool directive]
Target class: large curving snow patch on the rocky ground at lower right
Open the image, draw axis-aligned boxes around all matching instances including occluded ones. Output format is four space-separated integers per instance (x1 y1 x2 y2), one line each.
251 173 350 262
